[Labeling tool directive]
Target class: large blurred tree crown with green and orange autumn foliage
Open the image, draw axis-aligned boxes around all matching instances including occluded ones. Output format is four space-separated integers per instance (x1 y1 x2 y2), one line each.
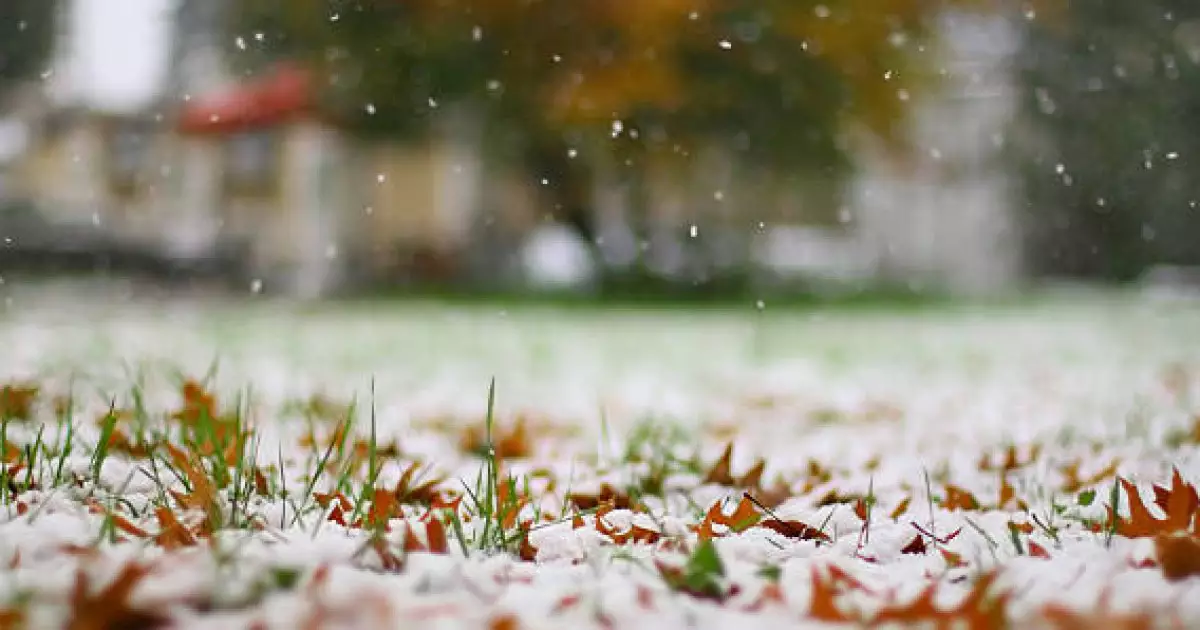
230 0 984 282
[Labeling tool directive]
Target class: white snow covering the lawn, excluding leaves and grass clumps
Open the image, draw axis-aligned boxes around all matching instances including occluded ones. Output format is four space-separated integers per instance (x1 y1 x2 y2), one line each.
0 282 1200 629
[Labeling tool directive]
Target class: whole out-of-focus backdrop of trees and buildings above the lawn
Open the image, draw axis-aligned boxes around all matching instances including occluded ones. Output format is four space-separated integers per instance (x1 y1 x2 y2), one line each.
0 0 1200 305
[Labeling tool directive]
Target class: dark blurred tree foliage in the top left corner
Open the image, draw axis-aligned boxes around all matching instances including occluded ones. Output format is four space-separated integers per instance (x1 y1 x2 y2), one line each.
0 0 59 102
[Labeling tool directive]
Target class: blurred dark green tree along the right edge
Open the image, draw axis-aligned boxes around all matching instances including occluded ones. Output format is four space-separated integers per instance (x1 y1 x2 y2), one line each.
1012 0 1200 278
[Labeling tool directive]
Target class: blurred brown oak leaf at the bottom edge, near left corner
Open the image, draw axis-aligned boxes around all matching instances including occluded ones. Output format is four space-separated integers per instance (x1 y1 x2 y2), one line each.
66 563 170 630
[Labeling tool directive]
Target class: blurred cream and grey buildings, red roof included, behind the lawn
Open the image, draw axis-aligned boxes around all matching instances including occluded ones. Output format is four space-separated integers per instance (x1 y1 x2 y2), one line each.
2 0 1021 295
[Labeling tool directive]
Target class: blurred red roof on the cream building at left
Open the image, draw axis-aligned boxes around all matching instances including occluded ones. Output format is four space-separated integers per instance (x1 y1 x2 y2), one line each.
178 65 313 133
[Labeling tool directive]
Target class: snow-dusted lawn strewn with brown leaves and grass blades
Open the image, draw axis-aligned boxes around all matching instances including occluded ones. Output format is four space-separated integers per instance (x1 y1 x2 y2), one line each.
0 285 1200 629
